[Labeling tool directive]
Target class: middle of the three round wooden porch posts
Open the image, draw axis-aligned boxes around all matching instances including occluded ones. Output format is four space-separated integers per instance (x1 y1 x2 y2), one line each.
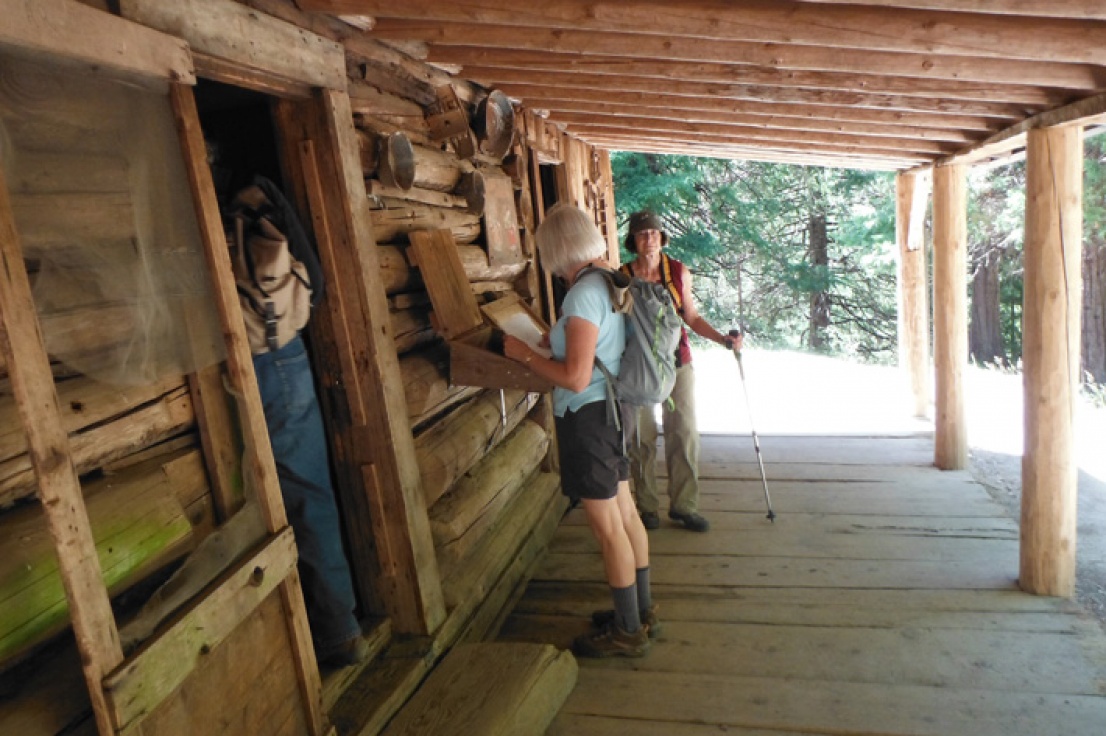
933 165 968 470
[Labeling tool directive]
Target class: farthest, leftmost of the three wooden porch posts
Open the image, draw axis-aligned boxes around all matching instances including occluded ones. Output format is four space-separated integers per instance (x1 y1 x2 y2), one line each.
895 168 930 417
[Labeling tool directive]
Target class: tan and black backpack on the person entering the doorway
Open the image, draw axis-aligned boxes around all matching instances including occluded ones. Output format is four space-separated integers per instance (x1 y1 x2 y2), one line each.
227 176 322 354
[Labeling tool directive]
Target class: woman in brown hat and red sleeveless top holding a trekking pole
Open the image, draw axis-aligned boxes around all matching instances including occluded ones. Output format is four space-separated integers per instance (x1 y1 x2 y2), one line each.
622 210 741 531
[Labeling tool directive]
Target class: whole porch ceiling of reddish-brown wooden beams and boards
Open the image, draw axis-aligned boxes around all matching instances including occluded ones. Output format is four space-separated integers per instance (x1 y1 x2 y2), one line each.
295 0 1106 169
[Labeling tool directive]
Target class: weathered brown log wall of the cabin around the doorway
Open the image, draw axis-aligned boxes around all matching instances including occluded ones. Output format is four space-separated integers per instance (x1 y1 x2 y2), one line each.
0 0 617 735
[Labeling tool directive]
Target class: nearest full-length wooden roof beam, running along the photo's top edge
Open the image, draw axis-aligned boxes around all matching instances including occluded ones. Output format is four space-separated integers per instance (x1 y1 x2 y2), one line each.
296 0 1106 65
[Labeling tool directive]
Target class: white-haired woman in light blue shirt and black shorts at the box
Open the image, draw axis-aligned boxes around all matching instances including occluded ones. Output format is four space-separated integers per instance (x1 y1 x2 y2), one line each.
503 205 657 656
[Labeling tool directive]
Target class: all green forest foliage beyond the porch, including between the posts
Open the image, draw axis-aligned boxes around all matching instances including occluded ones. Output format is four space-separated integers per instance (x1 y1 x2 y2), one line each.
612 135 1106 374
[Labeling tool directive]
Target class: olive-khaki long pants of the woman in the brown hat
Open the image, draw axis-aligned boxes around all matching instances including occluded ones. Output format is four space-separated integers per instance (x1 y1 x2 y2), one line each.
629 364 699 514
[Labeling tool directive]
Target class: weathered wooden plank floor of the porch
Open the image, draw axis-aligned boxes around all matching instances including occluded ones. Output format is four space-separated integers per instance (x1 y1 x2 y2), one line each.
500 436 1106 736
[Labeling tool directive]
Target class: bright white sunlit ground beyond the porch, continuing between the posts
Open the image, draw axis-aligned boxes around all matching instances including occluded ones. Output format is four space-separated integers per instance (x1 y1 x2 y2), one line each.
695 349 1106 481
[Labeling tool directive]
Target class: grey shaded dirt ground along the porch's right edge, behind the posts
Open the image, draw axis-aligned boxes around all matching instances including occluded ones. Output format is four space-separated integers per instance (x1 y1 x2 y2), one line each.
968 448 1106 629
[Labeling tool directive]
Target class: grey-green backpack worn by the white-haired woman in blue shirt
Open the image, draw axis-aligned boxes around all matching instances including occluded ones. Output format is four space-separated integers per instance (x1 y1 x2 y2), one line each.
585 267 684 428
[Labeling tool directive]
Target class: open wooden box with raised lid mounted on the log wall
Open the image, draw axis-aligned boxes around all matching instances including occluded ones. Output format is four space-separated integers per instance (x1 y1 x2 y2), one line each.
407 230 553 392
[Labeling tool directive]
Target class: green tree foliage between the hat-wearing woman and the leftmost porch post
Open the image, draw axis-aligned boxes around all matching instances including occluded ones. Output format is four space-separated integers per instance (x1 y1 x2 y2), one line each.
612 153 896 360
